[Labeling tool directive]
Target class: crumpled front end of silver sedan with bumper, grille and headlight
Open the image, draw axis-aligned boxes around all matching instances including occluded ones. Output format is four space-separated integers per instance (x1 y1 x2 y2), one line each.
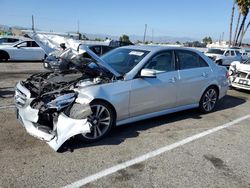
15 82 92 151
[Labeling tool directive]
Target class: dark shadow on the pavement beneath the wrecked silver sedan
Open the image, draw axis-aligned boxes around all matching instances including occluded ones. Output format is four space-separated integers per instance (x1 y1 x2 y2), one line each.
59 95 246 152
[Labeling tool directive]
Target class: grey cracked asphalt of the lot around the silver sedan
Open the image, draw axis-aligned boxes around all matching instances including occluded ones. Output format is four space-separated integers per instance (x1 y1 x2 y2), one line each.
0 63 250 188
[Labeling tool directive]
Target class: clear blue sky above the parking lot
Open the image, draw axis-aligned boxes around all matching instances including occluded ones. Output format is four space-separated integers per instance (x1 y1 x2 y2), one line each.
0 0 241 39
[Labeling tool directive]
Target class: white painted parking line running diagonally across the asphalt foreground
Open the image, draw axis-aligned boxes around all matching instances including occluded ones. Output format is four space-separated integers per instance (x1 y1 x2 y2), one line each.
65 114 250 188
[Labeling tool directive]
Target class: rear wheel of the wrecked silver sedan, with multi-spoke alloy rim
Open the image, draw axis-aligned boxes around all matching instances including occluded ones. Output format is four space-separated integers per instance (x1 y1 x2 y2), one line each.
199 86 219 113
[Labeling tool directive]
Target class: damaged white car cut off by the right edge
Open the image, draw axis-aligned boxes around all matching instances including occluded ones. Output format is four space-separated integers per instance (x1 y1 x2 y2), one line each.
229 59 250 90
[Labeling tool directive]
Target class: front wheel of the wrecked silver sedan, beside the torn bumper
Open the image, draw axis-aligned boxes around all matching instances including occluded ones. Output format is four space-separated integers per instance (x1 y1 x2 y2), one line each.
75 101 115 143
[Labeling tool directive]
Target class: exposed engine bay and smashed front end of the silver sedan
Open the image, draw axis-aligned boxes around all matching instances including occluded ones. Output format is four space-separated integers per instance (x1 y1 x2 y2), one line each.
15 47 116 150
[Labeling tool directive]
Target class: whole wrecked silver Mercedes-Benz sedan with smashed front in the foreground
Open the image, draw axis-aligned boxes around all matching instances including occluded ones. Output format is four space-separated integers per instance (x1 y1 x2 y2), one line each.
15 46 228 150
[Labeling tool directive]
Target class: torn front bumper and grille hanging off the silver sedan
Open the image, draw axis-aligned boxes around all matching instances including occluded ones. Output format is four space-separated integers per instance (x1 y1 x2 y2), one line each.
15 82 91 151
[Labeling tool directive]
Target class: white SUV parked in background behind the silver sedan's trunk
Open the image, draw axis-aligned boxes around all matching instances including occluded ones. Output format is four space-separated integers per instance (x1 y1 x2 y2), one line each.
204 48 242 66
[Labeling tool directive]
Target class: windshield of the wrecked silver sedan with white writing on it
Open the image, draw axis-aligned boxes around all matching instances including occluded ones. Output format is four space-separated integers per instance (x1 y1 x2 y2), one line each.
101 48 149 75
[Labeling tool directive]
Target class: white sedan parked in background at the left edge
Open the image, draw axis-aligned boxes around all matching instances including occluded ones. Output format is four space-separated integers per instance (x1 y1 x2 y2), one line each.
0 39 46 61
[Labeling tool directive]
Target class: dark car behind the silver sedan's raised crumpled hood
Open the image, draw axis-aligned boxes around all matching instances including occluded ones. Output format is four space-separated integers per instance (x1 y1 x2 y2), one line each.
43 44 114 71
